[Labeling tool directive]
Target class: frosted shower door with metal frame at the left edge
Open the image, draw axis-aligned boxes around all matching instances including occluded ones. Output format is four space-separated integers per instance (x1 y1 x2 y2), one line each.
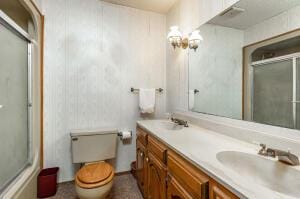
0 10 31 194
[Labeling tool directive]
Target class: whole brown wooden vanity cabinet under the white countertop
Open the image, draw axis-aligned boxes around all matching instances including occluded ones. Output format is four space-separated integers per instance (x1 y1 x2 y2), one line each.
136 127 238 199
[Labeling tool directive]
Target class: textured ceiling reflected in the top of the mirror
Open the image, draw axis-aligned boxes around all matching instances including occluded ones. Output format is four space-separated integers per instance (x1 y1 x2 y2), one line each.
209 0 300 30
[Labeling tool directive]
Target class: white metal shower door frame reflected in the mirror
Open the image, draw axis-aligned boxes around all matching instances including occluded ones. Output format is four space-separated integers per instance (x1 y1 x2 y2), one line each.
251 53 300 129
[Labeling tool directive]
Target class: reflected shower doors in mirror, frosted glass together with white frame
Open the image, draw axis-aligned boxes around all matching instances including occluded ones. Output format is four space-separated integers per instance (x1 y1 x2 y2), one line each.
251 53 300 129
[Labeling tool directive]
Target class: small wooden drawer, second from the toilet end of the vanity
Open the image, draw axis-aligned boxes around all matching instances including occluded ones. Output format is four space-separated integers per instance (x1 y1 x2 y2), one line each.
148 136 167 164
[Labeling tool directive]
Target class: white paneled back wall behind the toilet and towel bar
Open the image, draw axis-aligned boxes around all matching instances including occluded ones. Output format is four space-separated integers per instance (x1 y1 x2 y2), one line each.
43 0 166 181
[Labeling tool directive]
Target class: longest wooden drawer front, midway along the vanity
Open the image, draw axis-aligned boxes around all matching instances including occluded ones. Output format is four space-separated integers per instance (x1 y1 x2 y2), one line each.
167 151 209 199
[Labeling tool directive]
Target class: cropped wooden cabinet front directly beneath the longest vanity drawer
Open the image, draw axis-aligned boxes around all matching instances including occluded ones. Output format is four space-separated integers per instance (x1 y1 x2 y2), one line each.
167 175 193 199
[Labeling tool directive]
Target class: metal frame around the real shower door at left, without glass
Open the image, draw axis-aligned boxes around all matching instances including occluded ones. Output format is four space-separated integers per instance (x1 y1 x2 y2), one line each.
0 9 35 194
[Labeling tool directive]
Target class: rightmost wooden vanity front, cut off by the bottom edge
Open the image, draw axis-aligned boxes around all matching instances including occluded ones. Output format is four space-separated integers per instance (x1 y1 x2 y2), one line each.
209 180 238 199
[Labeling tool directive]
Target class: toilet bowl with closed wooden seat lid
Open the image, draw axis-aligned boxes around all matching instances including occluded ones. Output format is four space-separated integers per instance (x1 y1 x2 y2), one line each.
75 161 114 199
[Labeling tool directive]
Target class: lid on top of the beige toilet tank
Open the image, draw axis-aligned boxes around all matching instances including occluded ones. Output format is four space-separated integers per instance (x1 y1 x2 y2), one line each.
70 127 118 137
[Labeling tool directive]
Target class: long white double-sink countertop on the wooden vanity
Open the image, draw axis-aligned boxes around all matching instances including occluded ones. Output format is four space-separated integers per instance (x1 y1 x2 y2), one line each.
137 120 300 199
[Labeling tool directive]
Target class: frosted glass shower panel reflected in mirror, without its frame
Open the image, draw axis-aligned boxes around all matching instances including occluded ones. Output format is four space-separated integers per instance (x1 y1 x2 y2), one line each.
252 59 294 128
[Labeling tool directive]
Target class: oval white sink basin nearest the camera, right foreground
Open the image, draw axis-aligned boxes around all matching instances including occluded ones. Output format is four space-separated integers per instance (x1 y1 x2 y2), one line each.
217 151 300 198
